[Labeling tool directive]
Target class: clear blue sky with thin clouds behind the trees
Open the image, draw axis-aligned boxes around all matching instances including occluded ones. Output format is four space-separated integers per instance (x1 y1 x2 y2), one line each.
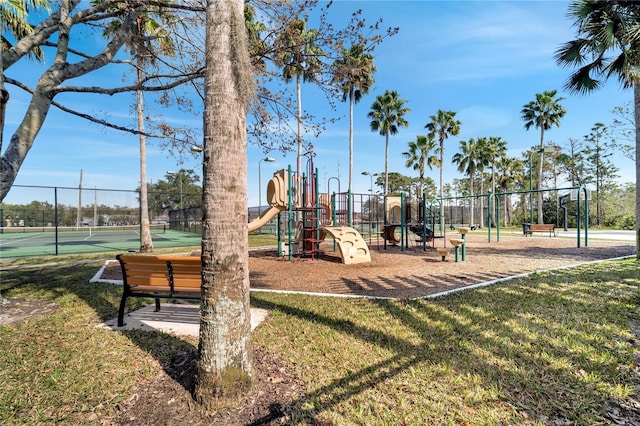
5 0 634 206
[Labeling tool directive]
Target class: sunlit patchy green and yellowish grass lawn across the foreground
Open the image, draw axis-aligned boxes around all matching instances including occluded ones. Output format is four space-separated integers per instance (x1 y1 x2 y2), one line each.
0 255 640 425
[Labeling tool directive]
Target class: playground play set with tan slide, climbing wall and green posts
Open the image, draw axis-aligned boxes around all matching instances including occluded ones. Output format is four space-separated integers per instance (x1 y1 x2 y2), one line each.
248 162 460 258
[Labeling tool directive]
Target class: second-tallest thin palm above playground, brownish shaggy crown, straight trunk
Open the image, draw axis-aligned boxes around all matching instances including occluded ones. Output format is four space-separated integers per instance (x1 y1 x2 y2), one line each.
333 44 376 198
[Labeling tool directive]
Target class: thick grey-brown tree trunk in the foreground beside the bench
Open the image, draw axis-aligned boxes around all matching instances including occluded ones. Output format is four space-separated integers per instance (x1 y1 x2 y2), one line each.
194 0 253 409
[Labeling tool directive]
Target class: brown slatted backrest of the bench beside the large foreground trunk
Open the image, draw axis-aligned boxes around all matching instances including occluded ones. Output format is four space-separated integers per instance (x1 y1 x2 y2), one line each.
116 254 202 288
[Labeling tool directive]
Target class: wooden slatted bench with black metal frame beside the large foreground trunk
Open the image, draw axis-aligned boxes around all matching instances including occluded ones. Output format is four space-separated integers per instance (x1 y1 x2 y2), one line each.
116 254 202 327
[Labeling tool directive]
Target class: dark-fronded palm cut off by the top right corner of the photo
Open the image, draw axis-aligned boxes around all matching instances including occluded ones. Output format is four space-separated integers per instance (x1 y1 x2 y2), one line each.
555 0 640 260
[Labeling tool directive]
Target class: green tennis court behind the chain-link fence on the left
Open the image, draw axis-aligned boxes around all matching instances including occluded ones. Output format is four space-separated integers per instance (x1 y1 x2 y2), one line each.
0 225 201 259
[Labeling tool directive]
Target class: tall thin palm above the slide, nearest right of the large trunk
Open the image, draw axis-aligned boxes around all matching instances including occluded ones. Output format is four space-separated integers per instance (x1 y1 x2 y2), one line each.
276 19 324 196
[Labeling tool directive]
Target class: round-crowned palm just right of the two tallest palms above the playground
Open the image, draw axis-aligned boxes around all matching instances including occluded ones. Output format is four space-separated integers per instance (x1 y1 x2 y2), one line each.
367 90 411 196
